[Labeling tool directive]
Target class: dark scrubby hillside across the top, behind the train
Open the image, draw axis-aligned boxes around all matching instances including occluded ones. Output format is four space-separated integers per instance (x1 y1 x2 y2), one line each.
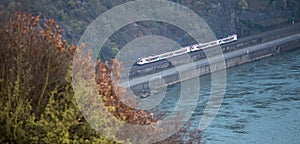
0 0 300 60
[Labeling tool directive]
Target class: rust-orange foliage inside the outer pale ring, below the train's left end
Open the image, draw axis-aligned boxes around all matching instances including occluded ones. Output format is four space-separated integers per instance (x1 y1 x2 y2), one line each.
95 59 158 125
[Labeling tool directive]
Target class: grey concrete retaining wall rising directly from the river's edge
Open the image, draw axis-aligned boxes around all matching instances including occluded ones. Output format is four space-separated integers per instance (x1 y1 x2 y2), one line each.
130 36 300 96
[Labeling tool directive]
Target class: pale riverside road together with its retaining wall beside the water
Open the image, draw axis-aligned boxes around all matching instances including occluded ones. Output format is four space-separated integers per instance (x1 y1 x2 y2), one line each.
121 31 300 96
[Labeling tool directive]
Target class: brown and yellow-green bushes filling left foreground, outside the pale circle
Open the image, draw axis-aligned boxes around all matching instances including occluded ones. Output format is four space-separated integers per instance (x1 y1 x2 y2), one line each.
0 13 113 143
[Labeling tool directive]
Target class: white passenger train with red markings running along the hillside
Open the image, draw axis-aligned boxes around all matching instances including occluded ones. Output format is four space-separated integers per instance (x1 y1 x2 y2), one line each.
136 34 238 65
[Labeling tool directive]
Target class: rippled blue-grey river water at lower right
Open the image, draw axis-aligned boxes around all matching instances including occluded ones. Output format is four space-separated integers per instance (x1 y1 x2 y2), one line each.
160 50 300 144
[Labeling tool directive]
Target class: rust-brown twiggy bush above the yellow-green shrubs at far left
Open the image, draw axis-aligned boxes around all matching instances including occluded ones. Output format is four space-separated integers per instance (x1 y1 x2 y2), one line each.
0 12 76 115
